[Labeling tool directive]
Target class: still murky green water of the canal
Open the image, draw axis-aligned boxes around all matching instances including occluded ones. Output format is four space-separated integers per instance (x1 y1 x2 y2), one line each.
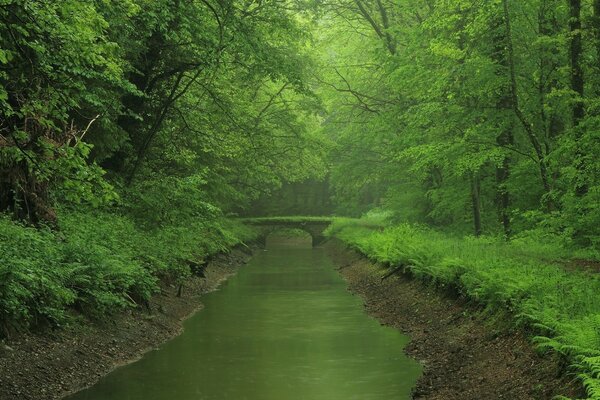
69 239 421 400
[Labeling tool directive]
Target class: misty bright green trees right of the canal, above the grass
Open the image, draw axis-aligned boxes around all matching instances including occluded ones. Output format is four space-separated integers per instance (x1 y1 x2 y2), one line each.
319 0 600 246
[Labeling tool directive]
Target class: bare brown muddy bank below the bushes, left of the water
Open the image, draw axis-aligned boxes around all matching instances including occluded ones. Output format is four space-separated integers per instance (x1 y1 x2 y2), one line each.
0 249 250 400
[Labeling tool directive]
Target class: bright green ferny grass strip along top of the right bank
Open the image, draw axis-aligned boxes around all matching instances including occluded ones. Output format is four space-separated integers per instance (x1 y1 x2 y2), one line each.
326 219 600 399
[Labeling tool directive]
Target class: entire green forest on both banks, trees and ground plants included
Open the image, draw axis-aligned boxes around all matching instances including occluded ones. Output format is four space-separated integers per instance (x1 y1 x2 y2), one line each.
0 0 600 399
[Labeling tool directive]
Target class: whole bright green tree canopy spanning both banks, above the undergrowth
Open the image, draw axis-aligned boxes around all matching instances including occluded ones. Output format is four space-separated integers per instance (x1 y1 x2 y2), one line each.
0 0 600 245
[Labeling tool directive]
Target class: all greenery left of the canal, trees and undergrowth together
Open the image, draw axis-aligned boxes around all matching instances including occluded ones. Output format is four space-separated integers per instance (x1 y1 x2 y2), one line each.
0 0 325 335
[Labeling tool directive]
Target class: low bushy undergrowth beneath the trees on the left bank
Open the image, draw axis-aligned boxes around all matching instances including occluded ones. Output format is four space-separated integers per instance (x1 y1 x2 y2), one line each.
0 209 255 337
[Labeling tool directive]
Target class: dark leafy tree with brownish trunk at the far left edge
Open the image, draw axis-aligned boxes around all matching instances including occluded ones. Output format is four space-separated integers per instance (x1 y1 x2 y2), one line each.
0 0 132 223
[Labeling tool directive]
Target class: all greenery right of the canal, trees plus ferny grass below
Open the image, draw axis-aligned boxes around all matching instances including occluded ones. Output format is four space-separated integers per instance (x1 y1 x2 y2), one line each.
316 0 600 398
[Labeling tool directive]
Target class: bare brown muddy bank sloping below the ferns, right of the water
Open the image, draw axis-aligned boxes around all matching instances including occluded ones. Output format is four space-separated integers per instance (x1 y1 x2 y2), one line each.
326 240 583 400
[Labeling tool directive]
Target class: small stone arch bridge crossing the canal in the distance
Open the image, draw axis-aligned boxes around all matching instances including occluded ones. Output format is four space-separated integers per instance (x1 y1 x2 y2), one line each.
243 217 333 246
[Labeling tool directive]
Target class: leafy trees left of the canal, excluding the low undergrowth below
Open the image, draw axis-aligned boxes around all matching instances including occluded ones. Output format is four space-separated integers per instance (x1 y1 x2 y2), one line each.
0 0 323 219
